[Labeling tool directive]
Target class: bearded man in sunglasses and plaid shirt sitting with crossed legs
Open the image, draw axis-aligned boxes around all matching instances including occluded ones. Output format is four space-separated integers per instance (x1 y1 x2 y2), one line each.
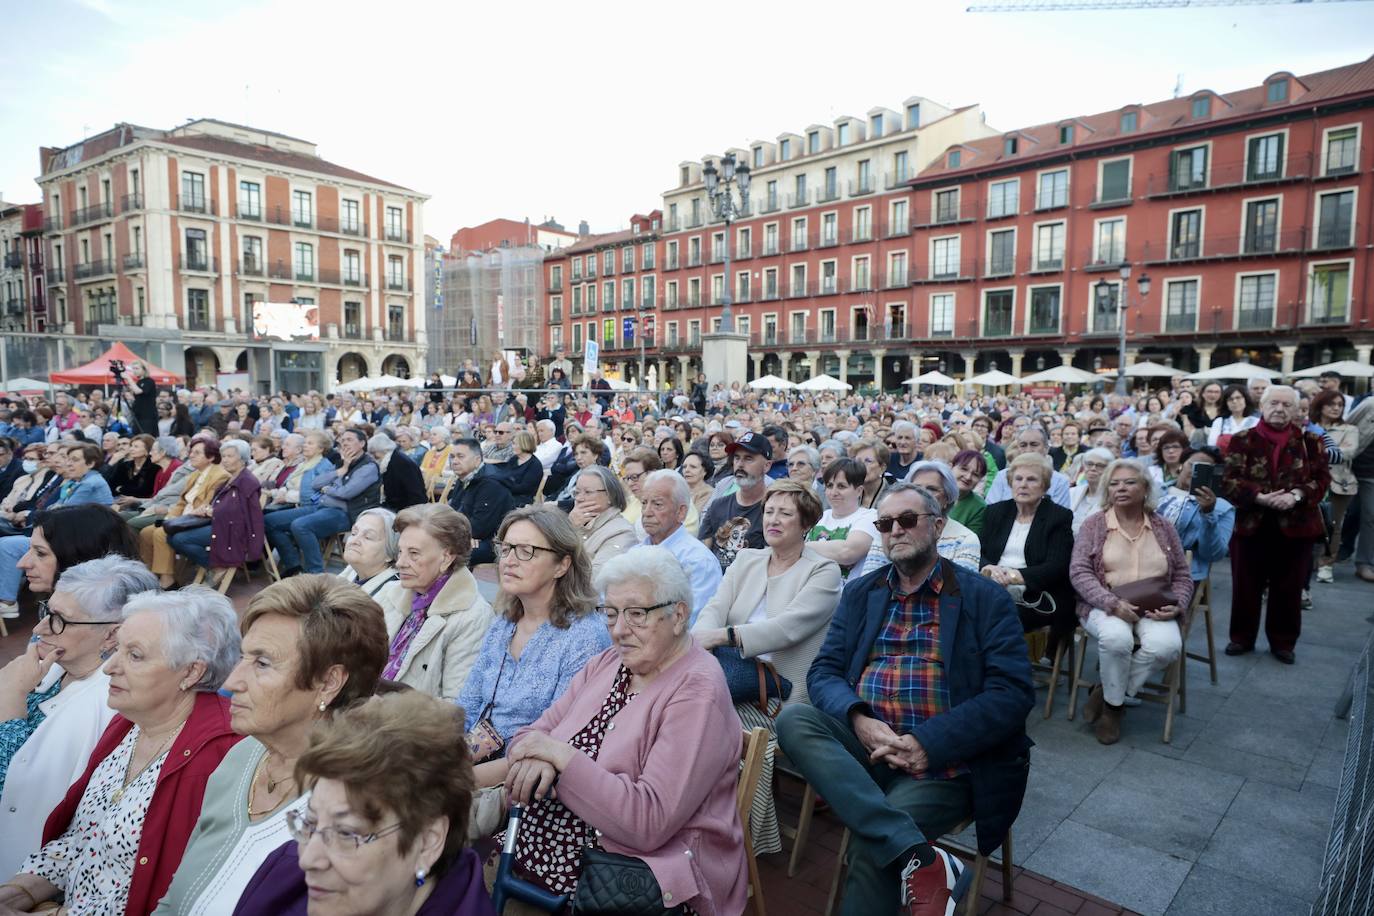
778 483 1035 916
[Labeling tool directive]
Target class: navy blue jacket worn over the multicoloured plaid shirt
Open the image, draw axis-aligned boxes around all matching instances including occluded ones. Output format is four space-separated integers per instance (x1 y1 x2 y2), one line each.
807 559 1035 854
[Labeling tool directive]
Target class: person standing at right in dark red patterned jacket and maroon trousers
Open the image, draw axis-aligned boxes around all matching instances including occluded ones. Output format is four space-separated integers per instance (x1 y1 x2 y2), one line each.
1221 385 1331 665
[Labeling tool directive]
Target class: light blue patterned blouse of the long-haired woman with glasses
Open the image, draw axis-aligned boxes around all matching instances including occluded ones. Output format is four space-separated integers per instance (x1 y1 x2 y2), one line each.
458 611 610 742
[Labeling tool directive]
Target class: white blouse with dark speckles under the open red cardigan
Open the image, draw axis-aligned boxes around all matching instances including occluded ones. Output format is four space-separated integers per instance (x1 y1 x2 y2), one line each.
19 726 168 916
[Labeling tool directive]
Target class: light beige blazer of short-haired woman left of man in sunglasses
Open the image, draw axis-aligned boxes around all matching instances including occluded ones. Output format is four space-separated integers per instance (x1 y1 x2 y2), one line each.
692 547 841 705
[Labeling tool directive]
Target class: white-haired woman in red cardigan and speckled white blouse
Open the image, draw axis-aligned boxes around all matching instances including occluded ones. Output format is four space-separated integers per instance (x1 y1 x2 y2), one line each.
0 586 239 916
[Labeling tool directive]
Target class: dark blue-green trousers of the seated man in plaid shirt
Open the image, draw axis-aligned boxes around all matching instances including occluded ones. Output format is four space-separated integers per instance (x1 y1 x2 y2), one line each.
778 705 973 916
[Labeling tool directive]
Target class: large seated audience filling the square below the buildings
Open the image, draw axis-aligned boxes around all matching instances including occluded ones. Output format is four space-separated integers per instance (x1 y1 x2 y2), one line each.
0 360 1352 916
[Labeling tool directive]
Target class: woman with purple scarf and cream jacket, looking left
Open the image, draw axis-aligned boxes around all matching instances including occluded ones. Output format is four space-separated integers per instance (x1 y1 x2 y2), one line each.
379 503 492 699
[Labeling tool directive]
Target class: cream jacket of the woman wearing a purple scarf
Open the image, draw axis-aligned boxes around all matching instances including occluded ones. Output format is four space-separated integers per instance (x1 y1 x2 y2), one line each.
376 567 495 700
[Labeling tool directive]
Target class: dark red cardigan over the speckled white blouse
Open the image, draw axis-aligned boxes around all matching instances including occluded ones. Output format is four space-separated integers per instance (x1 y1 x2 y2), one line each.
43 694 240 916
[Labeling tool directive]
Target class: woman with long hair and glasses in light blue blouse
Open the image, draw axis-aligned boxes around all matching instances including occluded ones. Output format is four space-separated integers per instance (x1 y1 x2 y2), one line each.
458 505 610 838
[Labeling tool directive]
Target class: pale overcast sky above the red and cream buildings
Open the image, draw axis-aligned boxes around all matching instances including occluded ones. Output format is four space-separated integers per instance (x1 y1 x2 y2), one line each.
0 0 1374 243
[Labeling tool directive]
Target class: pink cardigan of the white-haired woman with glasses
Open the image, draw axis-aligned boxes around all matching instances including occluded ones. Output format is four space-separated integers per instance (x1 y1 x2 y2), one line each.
511 645 749 916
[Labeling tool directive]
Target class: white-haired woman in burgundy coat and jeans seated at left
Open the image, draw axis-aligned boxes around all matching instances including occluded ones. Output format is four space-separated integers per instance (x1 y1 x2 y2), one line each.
168 439 265 585
